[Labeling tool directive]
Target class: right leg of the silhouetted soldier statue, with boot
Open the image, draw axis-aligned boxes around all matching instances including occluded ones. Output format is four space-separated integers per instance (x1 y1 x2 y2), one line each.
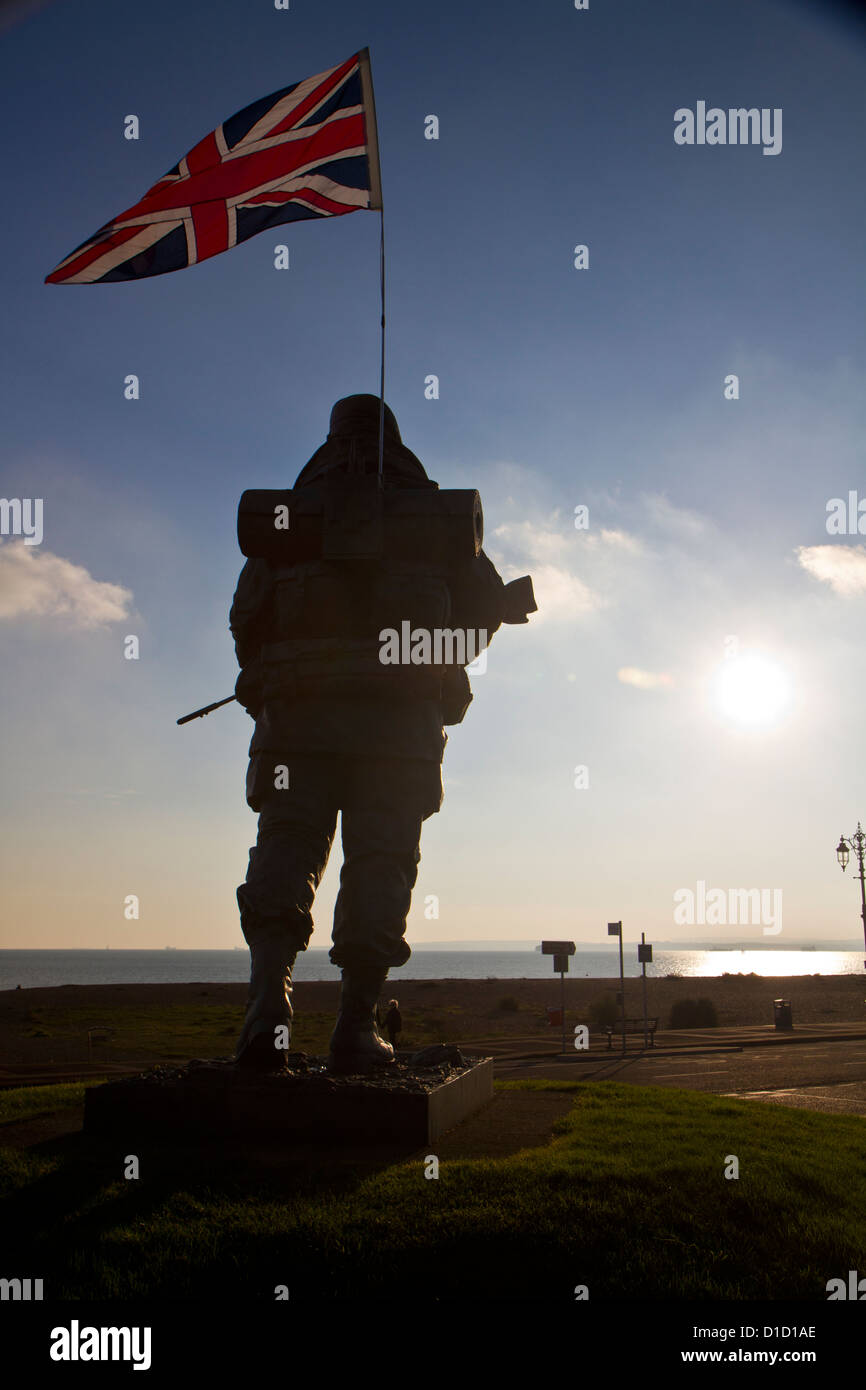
329 759 442 1072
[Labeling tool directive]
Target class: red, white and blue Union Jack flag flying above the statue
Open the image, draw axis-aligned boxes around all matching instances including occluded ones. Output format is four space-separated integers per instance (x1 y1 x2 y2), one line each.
46 49 382 285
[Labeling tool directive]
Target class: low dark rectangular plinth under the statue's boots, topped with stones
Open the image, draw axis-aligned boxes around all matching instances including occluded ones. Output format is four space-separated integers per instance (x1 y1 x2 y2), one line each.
85 1054 493 1147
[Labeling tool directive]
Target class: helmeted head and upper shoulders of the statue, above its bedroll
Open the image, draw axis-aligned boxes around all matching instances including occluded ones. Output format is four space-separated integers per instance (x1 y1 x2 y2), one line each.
295 396 436 488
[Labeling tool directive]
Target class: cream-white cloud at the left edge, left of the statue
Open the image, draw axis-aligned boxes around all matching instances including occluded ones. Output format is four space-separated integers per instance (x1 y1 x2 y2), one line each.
0 541 132 627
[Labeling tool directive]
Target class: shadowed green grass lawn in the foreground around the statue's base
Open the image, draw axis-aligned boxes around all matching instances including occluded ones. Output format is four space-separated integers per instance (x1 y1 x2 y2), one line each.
0 1081 866 1300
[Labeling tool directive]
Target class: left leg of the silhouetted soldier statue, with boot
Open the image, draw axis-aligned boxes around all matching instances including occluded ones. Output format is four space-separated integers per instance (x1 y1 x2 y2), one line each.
235 753 338 1070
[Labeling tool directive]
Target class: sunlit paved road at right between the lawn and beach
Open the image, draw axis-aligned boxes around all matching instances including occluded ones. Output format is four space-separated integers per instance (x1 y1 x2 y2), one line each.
496 1040 866 1115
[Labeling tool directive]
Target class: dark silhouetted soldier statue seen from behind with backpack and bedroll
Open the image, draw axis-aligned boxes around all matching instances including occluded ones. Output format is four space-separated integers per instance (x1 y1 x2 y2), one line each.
229 396 535 1073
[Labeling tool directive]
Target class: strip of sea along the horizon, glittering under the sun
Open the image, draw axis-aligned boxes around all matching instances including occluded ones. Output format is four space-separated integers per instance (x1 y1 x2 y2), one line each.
0 944 865 990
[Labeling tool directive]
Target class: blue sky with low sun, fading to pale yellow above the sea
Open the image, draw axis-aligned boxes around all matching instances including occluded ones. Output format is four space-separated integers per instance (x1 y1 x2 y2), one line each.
0 0 866 948
